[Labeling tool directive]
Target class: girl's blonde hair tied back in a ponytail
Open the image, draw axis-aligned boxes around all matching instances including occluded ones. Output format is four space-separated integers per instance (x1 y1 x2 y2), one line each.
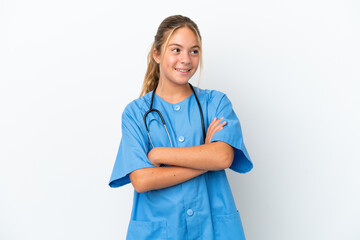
140 15 202 97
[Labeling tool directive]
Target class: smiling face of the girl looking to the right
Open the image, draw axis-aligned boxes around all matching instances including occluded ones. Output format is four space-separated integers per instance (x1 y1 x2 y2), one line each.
154 27 200 85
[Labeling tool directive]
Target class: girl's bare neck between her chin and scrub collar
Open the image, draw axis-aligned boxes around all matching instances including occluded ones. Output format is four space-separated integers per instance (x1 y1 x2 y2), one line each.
156 80 192 104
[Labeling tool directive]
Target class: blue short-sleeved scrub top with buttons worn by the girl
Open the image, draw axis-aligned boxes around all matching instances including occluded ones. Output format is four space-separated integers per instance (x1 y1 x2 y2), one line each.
109 87 253 240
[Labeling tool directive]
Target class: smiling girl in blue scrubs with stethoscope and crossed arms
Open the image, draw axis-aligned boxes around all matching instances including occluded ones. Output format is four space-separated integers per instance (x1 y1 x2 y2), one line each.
109 15 252 240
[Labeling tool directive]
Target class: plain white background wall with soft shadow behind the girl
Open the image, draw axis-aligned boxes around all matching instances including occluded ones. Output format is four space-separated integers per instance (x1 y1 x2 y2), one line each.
0 0 360 240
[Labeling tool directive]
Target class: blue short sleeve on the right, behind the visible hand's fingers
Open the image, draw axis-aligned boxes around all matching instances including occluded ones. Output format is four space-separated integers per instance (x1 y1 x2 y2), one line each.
211 94 253 173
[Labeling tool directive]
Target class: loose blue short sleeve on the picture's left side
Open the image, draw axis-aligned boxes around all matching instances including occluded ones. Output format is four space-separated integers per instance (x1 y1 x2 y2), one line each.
109 106 154 188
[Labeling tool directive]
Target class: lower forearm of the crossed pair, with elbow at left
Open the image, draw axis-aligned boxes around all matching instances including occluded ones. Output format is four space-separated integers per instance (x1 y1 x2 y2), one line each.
130 166 206 192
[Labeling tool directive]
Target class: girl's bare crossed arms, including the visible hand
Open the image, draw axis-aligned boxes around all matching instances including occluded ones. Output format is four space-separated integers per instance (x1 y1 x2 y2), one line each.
130 118 234 193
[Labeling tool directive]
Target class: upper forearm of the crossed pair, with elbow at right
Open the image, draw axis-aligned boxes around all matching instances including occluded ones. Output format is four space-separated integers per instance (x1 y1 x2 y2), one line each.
148 141 234 170
